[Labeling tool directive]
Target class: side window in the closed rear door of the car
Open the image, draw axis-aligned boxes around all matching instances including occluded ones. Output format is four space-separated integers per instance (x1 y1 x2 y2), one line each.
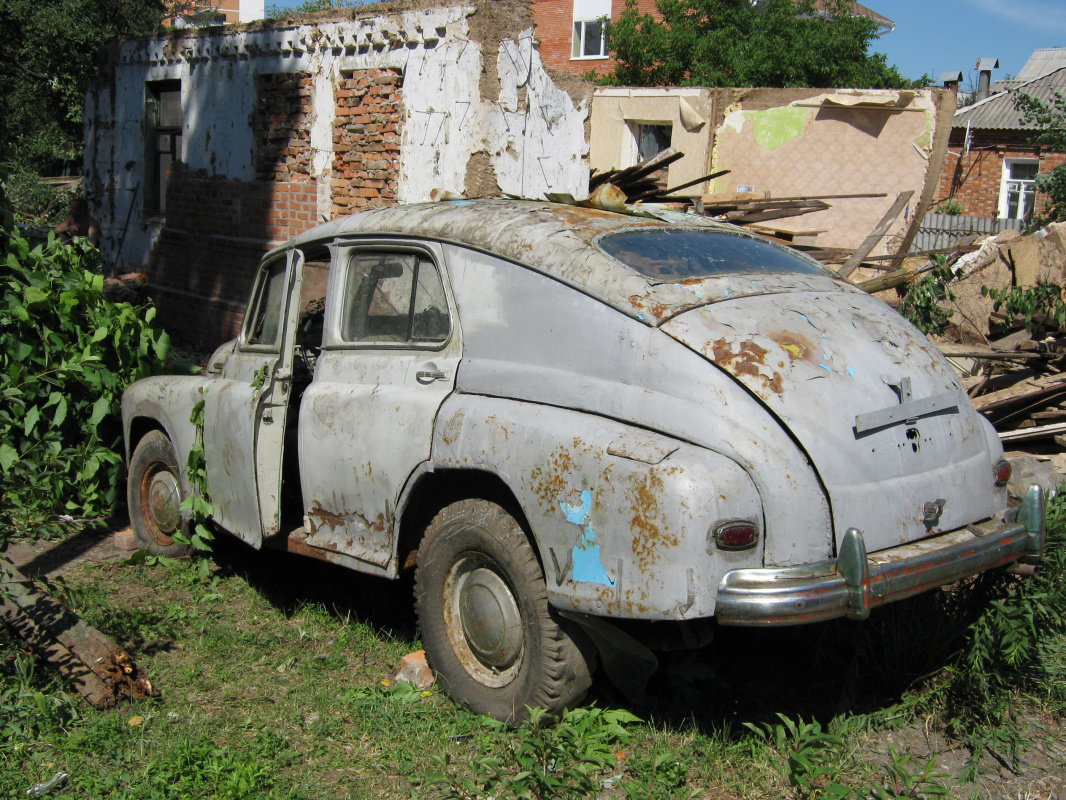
341 251 451 343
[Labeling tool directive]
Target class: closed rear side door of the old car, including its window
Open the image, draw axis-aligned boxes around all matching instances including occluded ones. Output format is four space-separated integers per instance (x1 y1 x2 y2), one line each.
300 242 461 573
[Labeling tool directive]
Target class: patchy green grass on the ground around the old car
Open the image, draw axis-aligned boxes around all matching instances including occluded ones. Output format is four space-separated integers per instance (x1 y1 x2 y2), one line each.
0 507 1066 800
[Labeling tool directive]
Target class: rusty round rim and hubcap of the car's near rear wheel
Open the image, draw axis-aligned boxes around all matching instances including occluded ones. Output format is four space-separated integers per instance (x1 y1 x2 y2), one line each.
445 555 524 687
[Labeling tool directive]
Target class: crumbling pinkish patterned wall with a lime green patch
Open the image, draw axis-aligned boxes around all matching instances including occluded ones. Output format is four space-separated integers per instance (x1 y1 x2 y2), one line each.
711 90 939 255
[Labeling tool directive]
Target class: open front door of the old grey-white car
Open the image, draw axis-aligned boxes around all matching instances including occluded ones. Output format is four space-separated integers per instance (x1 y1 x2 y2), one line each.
204 250 303 547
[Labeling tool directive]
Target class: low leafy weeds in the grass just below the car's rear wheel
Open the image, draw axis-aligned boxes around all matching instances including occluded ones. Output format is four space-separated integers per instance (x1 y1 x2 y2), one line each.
426 708 640 800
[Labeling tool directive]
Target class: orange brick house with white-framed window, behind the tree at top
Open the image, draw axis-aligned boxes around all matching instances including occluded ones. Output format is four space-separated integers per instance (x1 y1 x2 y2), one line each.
533 0 895 76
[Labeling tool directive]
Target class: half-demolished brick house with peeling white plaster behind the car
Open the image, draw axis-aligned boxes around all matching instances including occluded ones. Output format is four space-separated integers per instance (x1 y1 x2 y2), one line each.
85 0 592 346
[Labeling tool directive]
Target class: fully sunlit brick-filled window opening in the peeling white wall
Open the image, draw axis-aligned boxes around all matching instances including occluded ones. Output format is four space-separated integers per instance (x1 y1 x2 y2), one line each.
330 69 403 217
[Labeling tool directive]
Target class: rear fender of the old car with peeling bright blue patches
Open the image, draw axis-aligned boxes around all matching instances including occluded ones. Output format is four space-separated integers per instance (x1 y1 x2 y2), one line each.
432 395 765 620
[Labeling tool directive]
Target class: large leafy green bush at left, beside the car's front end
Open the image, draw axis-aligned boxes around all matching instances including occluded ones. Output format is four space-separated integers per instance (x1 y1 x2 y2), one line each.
0 166 169 544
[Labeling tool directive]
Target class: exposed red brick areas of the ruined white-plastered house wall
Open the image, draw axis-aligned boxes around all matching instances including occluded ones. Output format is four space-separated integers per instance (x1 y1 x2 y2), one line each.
146 69 403 347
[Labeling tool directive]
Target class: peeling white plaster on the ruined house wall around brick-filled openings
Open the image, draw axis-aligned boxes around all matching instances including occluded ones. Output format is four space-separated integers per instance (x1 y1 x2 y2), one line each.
85 6 588 270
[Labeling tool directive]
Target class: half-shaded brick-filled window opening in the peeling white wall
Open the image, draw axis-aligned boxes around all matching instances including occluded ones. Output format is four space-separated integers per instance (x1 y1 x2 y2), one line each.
252 73 311 181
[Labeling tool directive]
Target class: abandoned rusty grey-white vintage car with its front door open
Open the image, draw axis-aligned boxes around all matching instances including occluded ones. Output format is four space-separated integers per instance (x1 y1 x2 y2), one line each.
123 199 1044 720
